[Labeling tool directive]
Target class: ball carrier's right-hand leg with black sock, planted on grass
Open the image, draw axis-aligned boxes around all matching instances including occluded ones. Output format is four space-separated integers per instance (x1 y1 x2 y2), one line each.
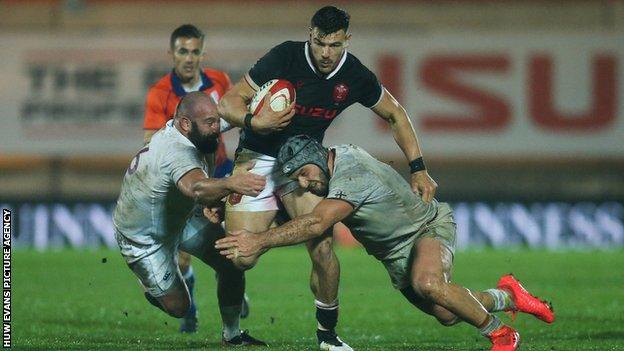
280 190 351 350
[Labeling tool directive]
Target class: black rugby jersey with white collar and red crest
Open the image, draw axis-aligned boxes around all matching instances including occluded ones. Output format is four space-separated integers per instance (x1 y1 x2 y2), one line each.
239 41 382 157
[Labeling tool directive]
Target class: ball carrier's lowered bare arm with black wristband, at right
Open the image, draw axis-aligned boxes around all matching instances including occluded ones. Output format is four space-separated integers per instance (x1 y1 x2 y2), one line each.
371 88 438 202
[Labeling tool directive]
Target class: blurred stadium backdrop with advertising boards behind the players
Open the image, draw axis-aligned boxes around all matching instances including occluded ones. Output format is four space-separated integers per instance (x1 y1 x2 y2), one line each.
0 0 624 349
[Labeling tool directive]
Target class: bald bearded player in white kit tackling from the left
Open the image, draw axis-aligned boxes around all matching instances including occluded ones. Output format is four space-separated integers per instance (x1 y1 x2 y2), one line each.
113 92 266 346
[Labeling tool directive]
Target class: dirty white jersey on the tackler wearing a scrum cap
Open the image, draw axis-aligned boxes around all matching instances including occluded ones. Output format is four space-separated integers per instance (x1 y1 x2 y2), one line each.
327 145 438 260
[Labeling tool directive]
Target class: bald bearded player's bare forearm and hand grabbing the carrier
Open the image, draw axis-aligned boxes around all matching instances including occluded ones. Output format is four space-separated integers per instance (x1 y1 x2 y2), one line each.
177 162 266 205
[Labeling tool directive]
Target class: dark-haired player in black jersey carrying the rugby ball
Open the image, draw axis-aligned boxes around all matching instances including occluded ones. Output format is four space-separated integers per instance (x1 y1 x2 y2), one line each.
219 6 437 351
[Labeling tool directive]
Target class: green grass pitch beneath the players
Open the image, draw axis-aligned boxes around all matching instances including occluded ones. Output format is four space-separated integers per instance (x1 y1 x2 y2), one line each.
12 247 624 350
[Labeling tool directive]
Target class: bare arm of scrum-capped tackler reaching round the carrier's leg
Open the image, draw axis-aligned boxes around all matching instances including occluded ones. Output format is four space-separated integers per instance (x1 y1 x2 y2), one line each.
215 199 353 259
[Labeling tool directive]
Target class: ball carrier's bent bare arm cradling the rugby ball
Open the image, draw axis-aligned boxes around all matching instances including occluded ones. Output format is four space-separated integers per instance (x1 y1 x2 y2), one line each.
218 78 295 134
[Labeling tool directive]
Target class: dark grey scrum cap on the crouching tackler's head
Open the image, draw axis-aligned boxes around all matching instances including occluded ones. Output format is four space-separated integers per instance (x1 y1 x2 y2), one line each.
277 135 329 177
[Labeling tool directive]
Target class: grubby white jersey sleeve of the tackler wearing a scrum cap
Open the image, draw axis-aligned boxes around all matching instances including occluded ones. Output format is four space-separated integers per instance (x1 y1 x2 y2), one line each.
326 170 373 208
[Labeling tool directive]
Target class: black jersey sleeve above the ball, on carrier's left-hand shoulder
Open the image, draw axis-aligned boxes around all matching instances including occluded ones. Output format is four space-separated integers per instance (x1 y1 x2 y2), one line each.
245 42 289 90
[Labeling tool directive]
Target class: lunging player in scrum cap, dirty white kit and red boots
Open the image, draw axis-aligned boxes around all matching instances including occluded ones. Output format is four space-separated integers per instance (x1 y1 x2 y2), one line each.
217 135 555 351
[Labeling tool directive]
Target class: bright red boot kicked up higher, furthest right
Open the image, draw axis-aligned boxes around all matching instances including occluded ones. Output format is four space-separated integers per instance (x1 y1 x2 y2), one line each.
496 274 555 323
